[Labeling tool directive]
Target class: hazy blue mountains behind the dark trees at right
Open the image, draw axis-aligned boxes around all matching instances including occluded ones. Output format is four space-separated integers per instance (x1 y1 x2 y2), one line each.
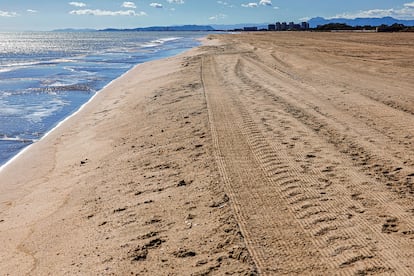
308 16 414 28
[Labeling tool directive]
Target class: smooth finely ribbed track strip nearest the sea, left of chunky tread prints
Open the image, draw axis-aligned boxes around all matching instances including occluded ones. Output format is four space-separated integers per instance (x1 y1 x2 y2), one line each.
202 56 329 274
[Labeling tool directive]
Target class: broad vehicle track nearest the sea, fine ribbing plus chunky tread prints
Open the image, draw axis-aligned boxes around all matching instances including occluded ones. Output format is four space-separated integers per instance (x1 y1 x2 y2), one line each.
202 49 409 275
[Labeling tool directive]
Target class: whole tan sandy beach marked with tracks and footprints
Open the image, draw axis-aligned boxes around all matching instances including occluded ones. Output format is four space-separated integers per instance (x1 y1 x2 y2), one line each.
0 33 414 275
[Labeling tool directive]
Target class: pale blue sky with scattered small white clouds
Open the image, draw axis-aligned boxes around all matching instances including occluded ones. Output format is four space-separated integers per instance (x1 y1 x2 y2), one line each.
0 0 414 31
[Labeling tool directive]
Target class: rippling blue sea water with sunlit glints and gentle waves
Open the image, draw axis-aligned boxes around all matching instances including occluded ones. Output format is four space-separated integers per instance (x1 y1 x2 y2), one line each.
0 32 206 167
